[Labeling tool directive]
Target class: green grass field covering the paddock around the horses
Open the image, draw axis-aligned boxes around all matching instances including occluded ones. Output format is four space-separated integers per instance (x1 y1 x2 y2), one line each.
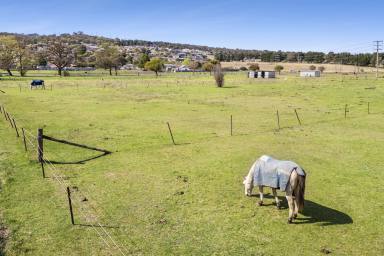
0 73 384 255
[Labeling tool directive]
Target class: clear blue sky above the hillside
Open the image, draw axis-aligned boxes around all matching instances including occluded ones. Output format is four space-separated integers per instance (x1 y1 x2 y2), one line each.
0 0 384 52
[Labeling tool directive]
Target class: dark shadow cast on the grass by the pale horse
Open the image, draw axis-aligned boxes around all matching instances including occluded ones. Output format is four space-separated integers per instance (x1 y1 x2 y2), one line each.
264 194 353 226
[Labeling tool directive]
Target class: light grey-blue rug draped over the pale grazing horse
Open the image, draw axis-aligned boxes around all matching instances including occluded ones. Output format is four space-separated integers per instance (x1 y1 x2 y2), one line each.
253 156 305 191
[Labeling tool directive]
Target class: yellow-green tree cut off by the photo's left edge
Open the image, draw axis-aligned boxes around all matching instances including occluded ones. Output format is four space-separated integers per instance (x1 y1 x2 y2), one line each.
0 36 17 76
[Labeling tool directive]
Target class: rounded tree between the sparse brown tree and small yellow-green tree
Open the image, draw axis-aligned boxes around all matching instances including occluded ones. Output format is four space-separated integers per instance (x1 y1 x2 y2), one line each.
95 44 120 75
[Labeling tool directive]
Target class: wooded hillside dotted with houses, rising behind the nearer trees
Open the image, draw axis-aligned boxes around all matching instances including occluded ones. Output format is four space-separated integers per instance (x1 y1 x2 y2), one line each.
0 32 378 66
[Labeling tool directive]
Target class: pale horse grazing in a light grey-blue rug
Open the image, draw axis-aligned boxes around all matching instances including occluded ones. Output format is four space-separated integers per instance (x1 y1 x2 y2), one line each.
243 155 306 223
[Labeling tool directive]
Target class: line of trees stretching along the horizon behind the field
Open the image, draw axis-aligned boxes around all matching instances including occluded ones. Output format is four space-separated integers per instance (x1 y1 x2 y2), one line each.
0 32 384 76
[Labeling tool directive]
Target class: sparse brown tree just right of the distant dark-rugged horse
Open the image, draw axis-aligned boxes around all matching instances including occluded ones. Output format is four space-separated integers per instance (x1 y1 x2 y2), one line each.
47 38 73 76
